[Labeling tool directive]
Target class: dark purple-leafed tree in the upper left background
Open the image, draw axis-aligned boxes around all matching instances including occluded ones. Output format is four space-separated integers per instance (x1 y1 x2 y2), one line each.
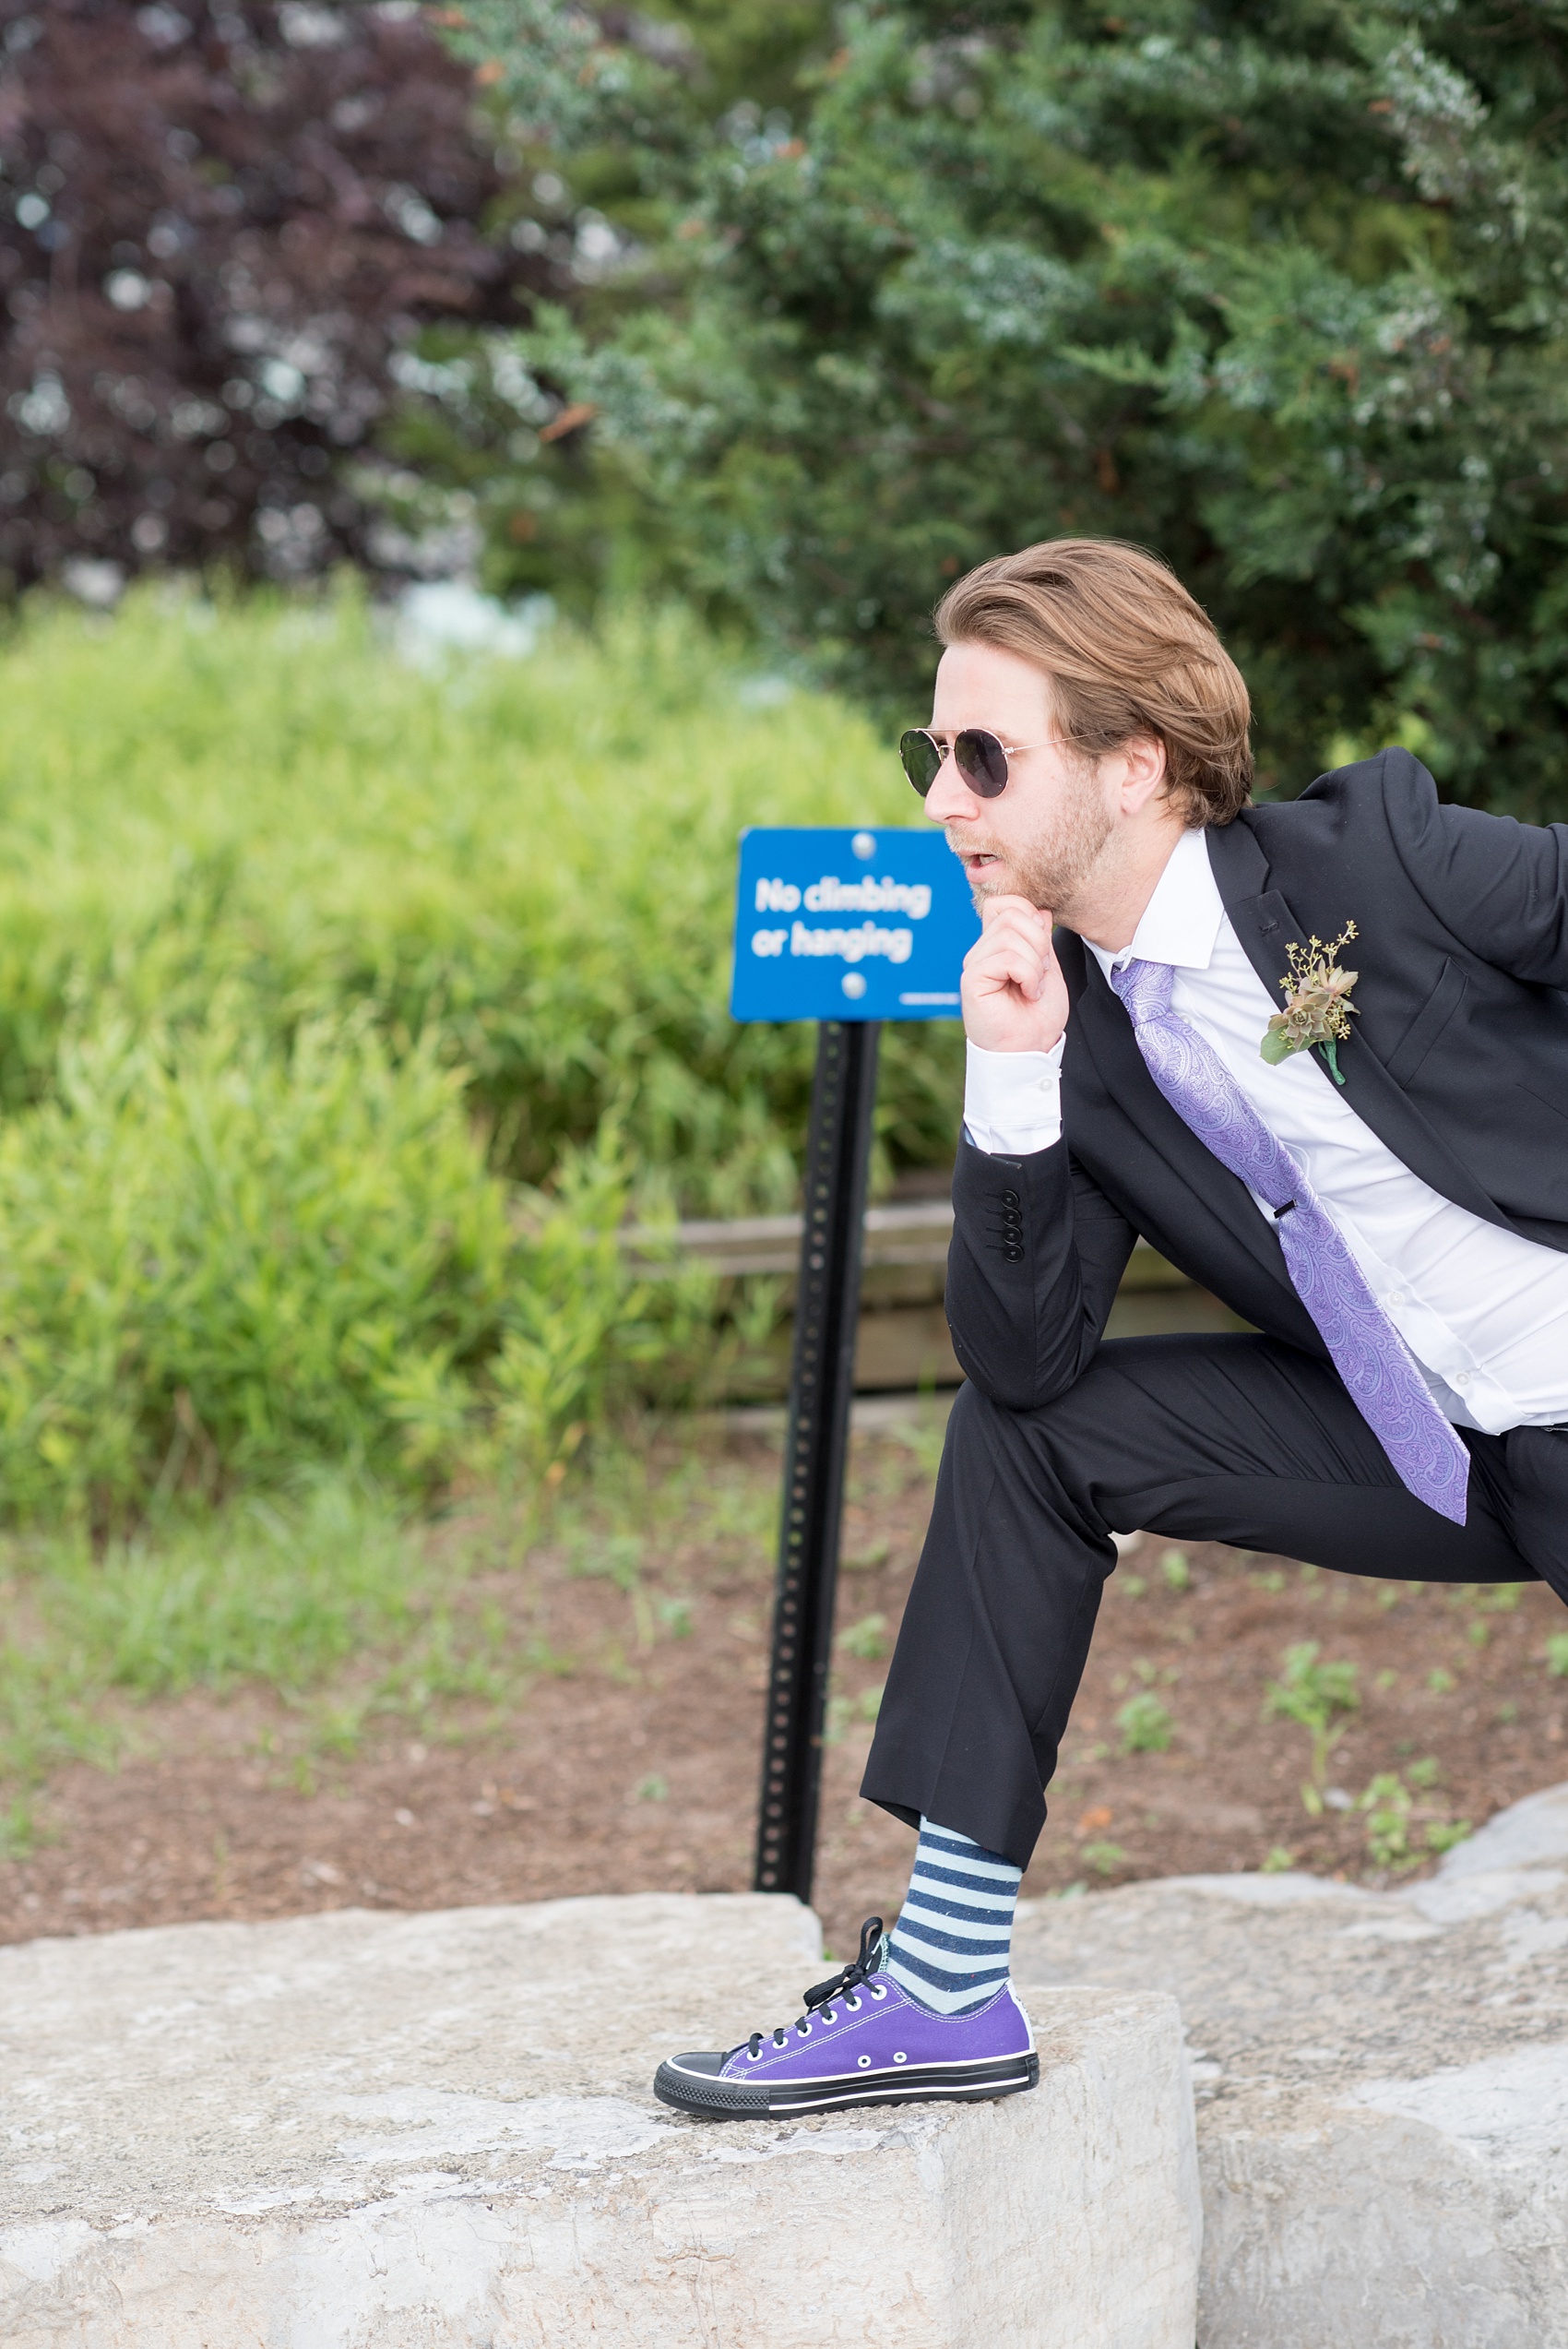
0 0 550 592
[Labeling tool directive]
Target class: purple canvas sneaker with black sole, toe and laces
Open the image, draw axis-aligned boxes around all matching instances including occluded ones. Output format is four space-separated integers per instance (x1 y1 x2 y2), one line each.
652 1917 1039 2121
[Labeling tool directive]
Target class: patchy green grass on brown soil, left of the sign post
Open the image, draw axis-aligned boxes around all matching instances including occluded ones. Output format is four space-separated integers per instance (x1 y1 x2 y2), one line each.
0 1414 789 1858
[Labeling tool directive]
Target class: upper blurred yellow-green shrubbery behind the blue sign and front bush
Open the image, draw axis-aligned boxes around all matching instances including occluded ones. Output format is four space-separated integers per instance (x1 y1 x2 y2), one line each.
0 592 960 1214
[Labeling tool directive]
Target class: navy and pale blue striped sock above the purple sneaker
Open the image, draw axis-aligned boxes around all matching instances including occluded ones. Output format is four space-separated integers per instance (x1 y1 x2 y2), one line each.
887 1818 1024 2015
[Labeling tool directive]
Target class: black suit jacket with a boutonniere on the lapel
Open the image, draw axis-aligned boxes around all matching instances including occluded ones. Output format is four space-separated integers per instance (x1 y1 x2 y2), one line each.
948 749 1568 1410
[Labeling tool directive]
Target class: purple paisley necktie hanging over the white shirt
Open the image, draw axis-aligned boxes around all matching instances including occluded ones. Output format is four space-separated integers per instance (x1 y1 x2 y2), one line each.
1111 963 1469 1524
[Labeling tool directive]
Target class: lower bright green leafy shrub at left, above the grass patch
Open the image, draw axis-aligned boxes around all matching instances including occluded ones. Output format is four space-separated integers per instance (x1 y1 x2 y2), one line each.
0 1008 702 1524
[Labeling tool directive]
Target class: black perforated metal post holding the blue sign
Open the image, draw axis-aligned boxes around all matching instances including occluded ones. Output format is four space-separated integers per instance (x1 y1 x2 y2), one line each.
755 1019 880 1902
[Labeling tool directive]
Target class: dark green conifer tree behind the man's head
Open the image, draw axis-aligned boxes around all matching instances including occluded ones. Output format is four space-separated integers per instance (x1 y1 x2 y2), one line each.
425 0 1568 817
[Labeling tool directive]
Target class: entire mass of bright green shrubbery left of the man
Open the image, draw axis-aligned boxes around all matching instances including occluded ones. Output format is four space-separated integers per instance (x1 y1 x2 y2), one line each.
0 590 960 1527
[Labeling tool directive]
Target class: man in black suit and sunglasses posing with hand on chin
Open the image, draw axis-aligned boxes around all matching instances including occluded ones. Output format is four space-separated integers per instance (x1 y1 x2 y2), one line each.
652 541 1568 2109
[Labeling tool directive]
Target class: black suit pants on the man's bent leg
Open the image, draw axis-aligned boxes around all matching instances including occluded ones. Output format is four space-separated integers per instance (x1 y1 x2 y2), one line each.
861 1337 1568 1867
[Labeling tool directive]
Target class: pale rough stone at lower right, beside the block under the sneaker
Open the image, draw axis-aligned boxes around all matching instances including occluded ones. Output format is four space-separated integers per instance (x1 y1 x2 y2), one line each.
1014 1785 1568 2349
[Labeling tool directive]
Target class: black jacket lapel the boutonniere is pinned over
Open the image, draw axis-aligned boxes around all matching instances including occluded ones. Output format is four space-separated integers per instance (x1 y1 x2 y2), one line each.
1211 817 1514 1231
